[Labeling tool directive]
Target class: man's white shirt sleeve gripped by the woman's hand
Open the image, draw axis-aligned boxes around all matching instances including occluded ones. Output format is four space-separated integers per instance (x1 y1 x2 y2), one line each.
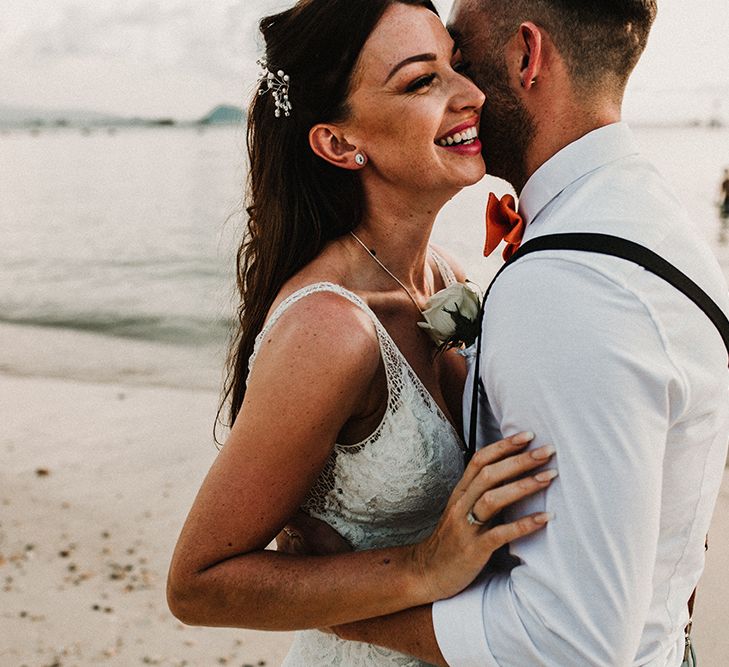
433 257 684 667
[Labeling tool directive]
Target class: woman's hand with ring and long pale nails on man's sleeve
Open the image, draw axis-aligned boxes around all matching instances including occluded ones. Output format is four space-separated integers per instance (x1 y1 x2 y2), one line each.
413 433 556 601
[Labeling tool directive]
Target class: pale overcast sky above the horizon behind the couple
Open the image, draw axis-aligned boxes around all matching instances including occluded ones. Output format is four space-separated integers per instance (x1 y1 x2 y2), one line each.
0 0 729 120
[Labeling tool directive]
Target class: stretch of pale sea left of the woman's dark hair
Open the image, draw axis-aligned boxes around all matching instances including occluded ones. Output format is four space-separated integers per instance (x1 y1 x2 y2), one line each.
0 129 245 352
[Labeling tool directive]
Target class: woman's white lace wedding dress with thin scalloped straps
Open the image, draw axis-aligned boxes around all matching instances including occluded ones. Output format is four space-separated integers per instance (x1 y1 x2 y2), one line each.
249 257 463 667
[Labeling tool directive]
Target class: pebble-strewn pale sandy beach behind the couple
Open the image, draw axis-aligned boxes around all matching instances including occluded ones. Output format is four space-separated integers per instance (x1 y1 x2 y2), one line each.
0 326 729 667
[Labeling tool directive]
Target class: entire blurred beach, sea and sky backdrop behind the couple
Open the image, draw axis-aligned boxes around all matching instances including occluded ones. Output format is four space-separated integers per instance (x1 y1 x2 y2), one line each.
0 0 729 666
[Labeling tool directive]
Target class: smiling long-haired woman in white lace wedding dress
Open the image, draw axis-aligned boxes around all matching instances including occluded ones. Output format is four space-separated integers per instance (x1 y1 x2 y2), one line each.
168 0 551 666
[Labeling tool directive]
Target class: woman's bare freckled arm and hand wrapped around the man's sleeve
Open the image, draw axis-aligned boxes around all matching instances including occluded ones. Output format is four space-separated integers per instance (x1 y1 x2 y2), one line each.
168 295 545 630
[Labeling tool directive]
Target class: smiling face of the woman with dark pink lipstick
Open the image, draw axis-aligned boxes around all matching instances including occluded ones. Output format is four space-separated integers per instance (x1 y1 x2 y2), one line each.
346 3 485 194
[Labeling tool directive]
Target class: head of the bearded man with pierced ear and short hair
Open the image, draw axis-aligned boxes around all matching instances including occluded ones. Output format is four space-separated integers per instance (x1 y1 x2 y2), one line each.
449 0 657 190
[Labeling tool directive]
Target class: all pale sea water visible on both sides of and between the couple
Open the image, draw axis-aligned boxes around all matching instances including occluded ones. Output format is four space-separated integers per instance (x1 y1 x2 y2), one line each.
0 128 729 386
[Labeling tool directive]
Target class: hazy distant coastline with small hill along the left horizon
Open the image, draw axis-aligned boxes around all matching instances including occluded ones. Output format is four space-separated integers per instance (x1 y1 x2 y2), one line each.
0 104 246 131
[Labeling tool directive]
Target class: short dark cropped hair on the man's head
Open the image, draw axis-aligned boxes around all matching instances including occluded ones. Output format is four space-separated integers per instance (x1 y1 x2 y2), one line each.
481 0 658 89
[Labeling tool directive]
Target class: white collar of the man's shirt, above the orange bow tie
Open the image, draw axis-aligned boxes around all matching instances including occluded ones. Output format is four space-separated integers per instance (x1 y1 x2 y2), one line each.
519 122 640 224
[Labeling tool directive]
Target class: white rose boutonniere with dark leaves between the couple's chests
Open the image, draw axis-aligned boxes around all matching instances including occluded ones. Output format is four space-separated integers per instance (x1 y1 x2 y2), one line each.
418 282 481 349
